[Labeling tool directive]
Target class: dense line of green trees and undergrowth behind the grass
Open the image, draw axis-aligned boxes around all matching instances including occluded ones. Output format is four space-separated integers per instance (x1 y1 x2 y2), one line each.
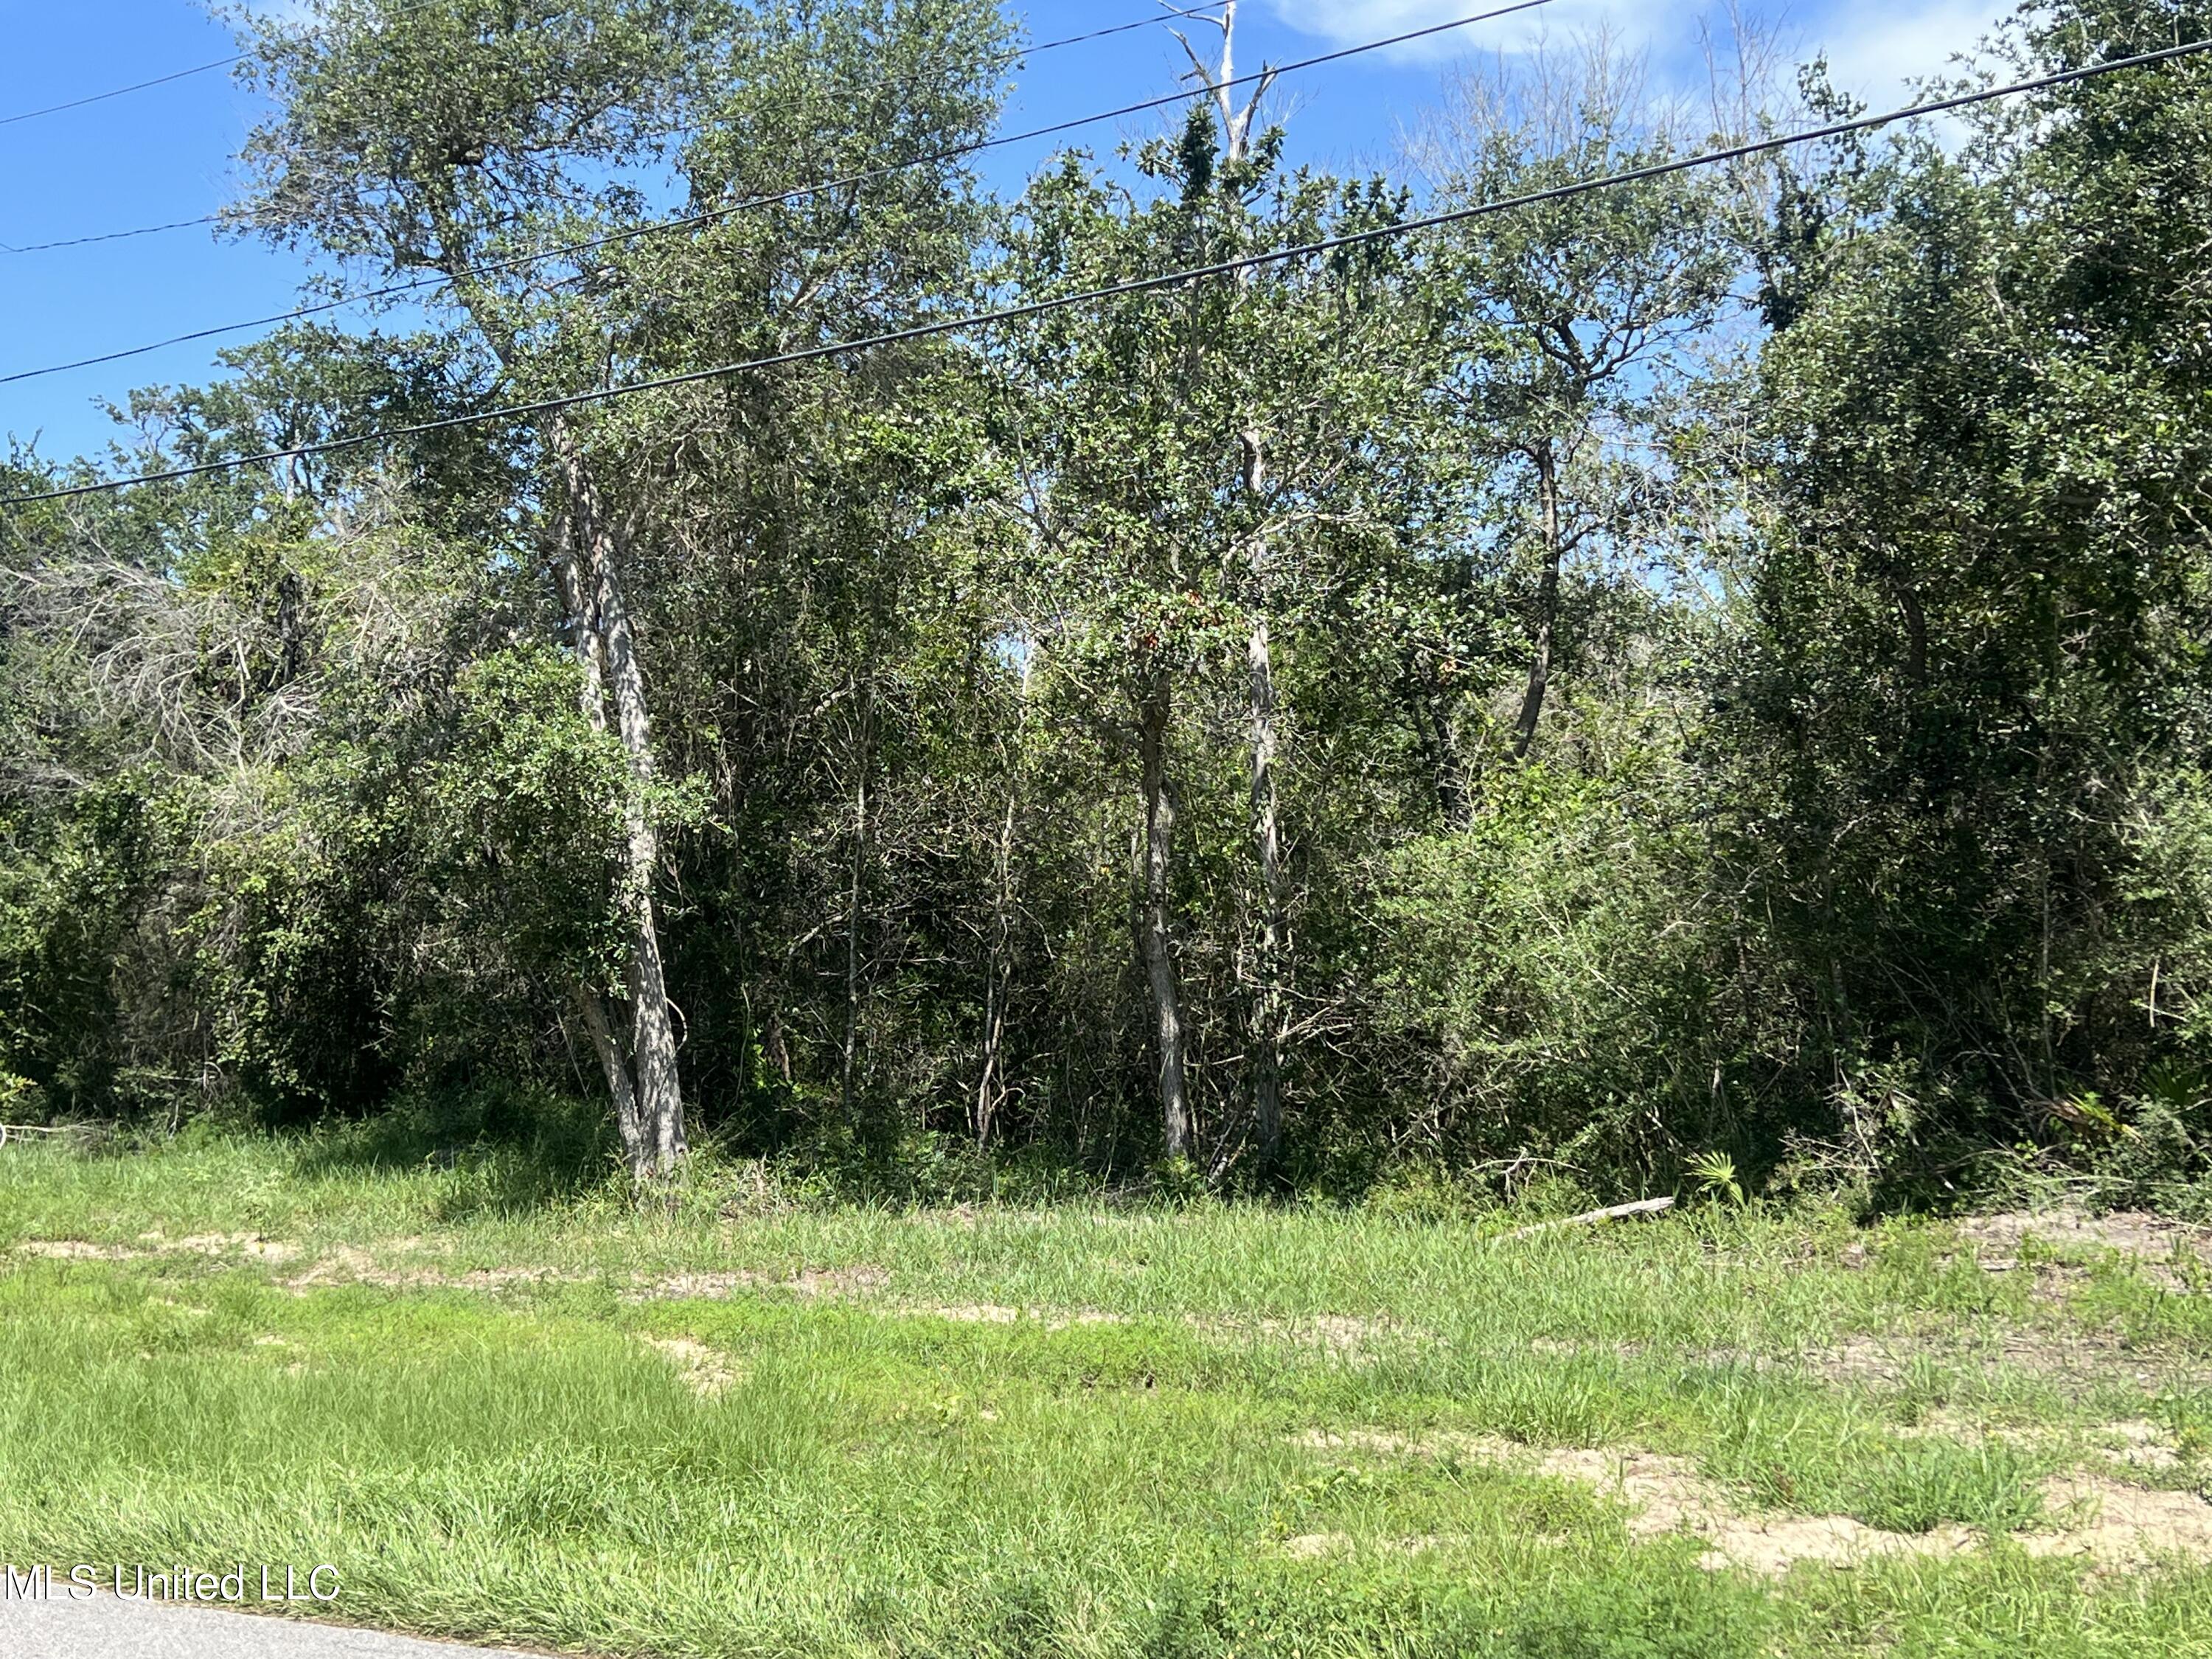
0 0 2212 1190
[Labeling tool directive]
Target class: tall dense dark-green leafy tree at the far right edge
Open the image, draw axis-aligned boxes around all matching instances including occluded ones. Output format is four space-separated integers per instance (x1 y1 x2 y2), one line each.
1705 9 2212 1194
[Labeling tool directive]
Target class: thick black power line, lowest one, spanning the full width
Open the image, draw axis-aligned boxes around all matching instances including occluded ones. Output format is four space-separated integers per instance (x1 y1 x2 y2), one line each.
0 40 2212 507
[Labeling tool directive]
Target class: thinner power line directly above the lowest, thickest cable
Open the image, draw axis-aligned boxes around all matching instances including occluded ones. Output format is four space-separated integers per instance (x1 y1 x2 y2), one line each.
0 0 1553 385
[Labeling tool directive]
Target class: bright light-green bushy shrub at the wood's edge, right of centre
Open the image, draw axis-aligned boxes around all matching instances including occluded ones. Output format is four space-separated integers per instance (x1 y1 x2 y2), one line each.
1382 752 1759 1186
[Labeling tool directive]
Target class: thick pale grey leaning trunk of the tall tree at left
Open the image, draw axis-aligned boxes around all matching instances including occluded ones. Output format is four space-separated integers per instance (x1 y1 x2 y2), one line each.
549 420 688 1179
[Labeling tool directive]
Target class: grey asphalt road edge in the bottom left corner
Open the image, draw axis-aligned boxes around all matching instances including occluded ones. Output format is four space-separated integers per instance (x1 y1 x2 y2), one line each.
0 1584 531 1659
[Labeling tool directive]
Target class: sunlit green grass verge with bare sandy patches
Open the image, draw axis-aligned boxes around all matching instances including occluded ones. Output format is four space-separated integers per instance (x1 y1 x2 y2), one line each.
0 1139 2212 1659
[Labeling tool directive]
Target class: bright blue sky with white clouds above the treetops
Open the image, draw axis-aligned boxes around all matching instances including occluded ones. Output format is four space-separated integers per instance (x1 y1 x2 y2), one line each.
0 0 2011 469
